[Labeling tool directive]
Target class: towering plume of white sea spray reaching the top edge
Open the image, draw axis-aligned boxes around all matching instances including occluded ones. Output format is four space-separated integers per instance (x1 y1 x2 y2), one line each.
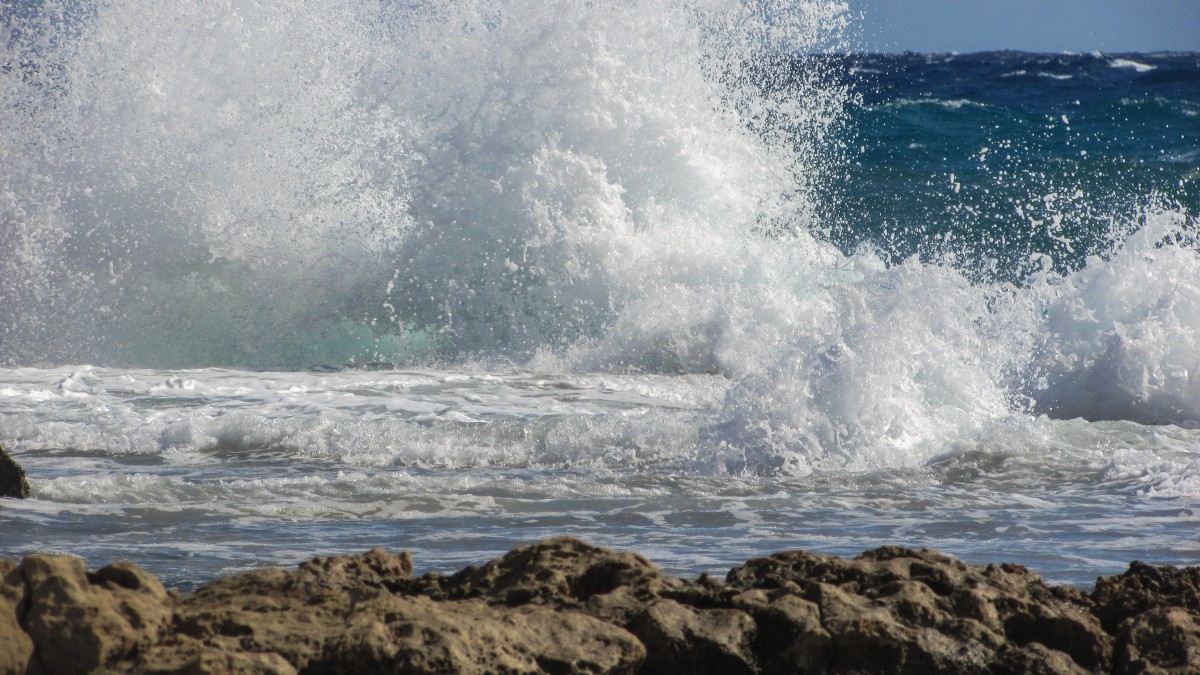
4 1 845 370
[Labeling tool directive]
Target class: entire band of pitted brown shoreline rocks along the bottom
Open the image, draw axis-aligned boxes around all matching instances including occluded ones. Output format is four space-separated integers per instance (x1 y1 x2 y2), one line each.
0 537 1200 675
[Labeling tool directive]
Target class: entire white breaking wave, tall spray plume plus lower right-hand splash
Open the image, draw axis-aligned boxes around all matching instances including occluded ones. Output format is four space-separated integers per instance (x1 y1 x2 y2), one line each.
0 0 1200 474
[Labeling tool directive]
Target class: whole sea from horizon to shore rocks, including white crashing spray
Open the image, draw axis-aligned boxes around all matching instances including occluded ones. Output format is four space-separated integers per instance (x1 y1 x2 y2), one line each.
0 0 1200 589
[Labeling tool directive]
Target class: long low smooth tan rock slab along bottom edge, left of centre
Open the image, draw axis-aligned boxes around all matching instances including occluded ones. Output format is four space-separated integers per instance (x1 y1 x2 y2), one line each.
141 597 644 673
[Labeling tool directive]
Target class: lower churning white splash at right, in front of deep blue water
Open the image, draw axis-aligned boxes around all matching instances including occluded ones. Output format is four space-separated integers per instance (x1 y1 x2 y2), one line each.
702 207 1200 474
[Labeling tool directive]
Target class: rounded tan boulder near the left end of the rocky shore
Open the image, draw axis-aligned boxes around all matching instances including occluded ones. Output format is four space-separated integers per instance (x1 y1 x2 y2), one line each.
19 555 170 674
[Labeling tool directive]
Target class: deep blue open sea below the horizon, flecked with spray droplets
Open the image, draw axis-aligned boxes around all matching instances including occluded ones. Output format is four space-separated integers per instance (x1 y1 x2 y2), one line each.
832 52 1200 279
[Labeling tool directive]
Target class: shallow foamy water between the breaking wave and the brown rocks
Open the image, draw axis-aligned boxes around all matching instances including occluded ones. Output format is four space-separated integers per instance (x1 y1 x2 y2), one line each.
0 369 1200 587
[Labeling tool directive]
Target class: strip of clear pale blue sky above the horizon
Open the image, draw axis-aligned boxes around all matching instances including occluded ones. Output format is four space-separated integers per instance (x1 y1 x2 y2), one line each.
846 0 1200 53
